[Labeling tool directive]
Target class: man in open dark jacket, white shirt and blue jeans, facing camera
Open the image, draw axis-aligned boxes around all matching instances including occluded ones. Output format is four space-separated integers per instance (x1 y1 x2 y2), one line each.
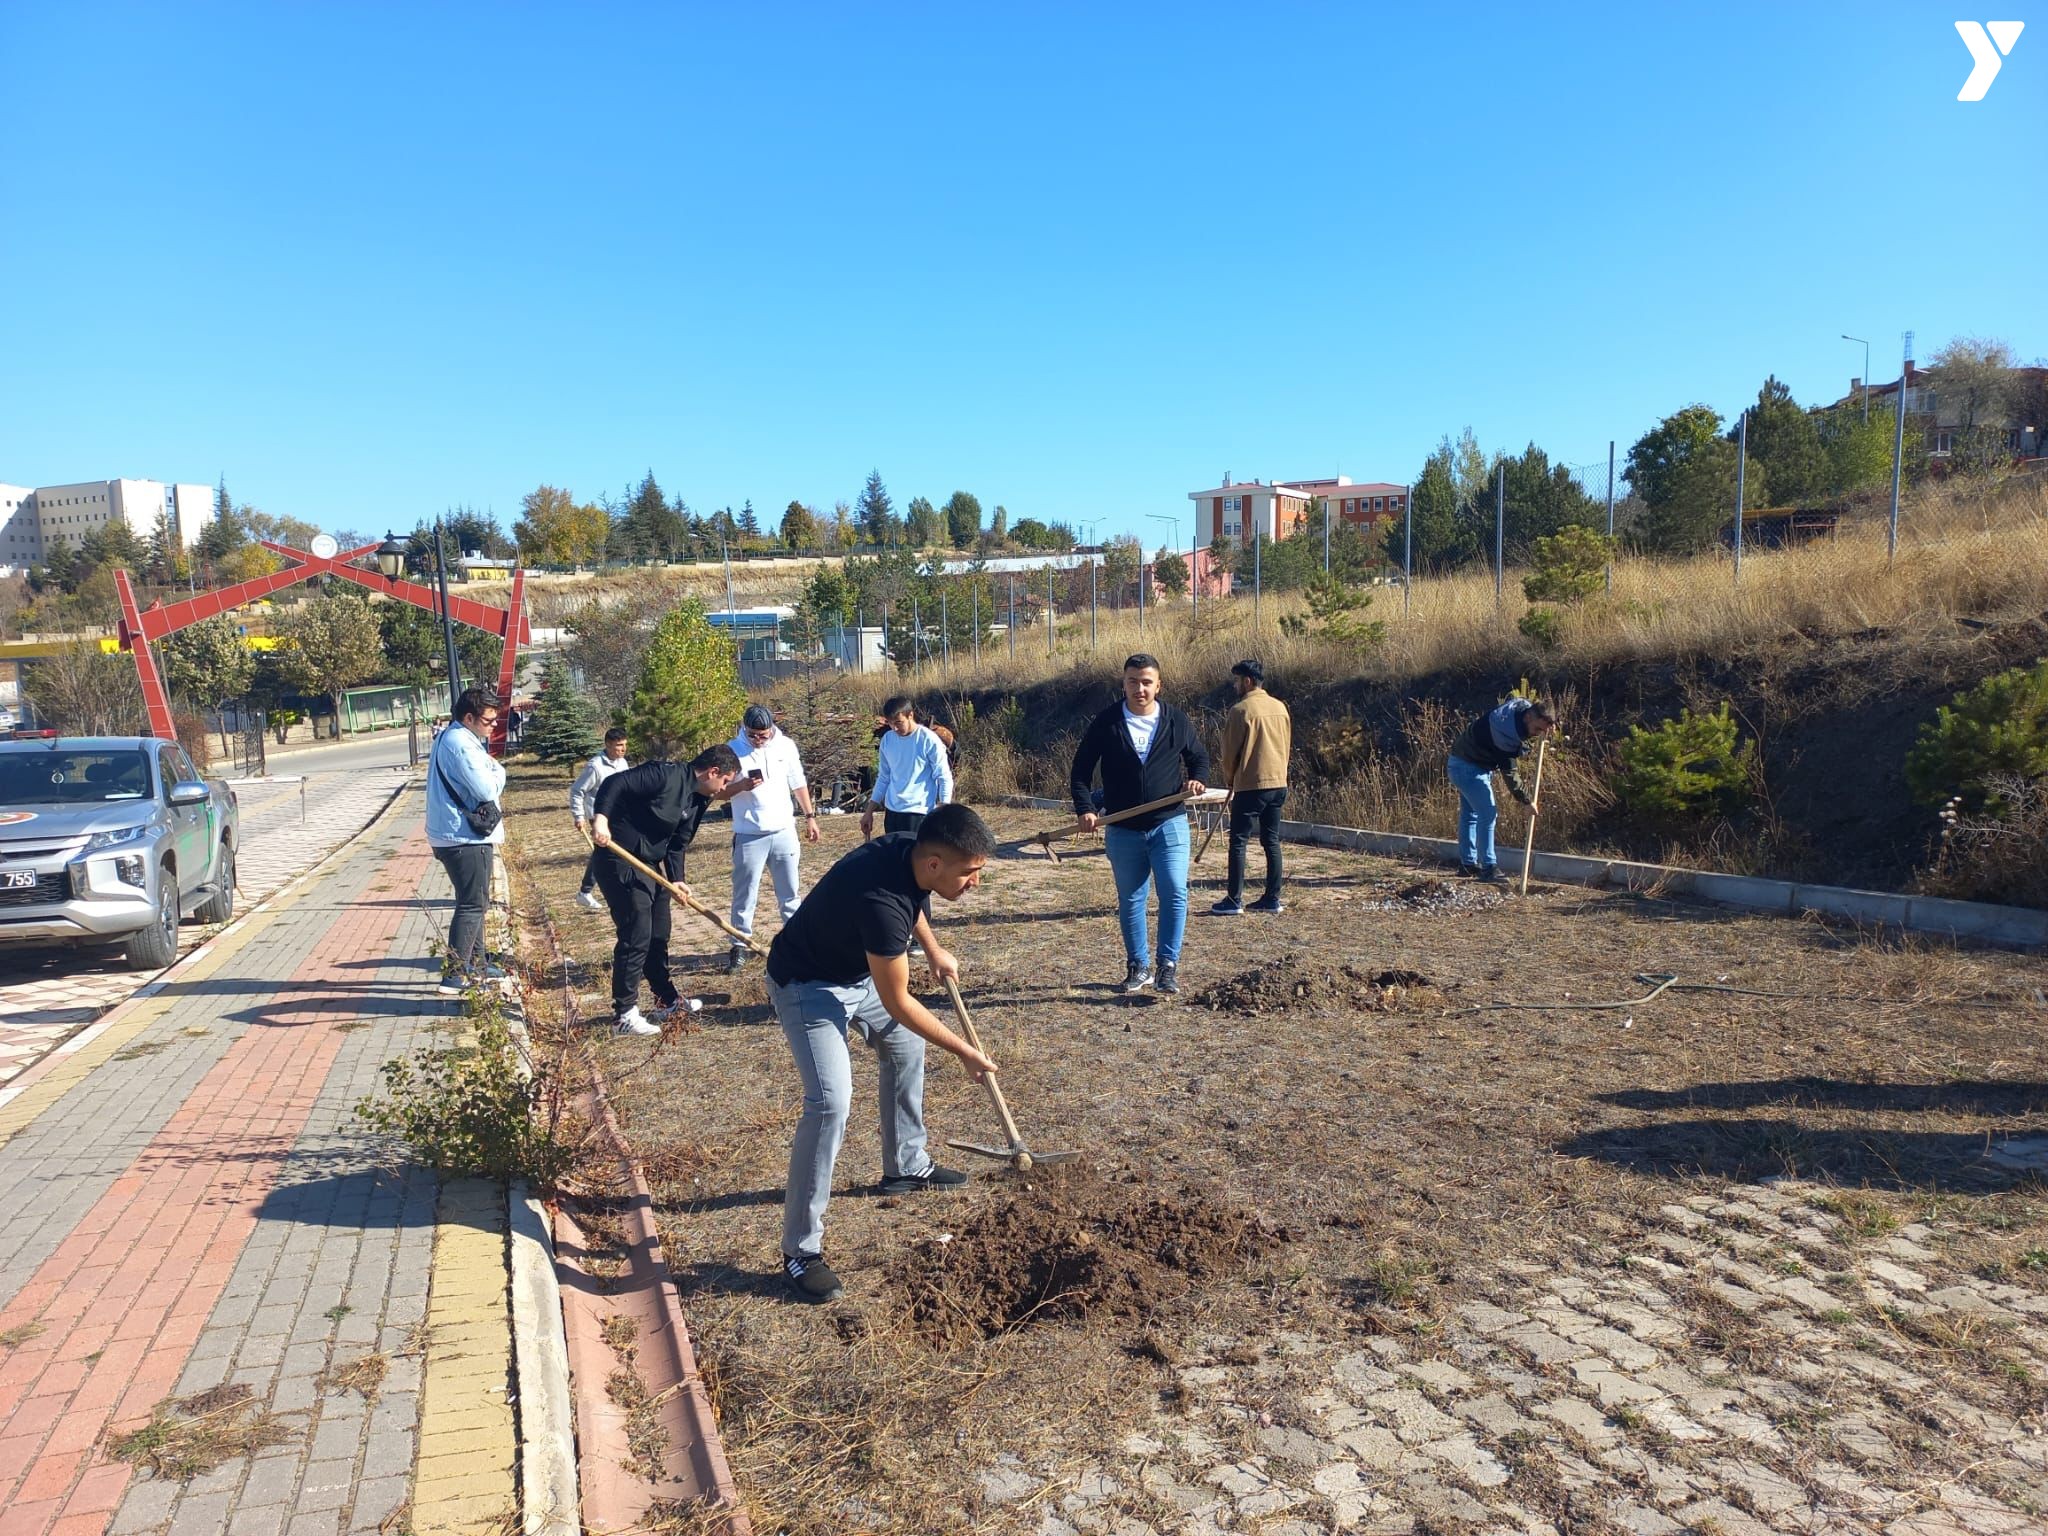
1069 651 1208 995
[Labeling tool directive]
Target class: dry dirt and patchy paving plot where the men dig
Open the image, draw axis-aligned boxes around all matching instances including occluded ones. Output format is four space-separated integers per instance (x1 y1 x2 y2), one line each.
508 770 2048 1536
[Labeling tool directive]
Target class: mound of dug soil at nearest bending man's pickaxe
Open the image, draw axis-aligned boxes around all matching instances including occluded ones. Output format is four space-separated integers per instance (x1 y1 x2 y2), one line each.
891 1167 1284 1341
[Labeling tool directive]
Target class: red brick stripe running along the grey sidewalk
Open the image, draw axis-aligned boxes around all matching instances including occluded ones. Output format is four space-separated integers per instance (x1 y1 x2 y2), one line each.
0 844 428 1536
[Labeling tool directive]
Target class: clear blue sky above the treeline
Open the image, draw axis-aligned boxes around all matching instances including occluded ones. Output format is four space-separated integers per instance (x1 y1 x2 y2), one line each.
0 0 2048 541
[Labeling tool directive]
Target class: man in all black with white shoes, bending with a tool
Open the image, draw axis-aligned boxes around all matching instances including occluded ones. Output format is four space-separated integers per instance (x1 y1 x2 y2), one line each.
590 741 739 1034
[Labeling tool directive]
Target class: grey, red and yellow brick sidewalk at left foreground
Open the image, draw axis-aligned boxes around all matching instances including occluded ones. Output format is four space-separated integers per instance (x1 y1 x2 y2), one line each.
0 791 516 1536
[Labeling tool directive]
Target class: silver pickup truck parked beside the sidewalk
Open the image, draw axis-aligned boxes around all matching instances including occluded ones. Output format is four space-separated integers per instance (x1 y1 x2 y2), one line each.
0 735 242 971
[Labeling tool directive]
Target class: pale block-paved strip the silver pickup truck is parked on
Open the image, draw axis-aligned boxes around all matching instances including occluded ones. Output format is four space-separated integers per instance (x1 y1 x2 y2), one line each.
0 770 403 1085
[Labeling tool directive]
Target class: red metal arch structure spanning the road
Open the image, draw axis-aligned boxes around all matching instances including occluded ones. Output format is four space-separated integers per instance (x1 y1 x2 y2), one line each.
115 539 532 754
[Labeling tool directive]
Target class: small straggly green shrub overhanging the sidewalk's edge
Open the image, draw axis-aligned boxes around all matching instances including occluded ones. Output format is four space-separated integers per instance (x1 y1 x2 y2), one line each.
356 997 569 1188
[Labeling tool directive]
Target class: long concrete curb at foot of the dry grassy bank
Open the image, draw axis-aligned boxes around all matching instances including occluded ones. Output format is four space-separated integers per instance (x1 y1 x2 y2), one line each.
1001 795 2048 948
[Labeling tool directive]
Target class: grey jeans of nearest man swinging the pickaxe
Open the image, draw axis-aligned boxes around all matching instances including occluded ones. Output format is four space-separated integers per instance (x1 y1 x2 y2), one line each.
768 979 932 1255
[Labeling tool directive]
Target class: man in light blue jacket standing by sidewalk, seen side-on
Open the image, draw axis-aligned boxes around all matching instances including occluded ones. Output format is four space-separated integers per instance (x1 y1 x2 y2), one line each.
426 688 506 997
